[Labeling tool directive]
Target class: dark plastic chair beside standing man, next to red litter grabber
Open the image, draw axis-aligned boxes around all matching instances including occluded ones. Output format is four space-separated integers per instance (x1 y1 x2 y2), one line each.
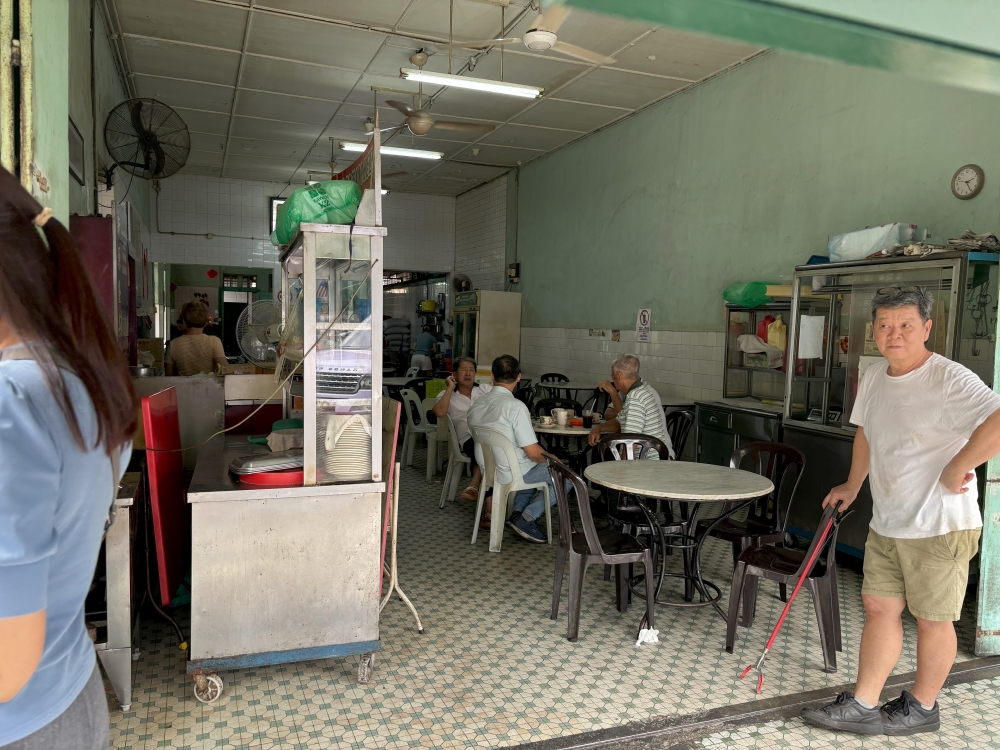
726 508 852 672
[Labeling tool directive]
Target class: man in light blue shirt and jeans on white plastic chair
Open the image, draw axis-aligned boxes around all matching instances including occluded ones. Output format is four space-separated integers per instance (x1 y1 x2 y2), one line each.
469 354 556 544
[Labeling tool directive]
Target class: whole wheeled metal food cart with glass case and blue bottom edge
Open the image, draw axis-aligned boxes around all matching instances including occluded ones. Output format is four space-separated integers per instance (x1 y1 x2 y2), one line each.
187 128 386 702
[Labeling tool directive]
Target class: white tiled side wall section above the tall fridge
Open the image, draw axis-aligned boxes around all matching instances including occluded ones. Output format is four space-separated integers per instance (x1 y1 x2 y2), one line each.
455 175 507 291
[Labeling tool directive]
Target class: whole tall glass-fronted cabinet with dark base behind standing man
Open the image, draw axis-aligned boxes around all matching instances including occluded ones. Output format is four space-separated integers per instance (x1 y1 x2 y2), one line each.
782 252 998 556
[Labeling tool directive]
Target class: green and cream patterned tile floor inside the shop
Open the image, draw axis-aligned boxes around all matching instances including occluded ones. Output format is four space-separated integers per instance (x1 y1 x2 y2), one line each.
111 450 976 750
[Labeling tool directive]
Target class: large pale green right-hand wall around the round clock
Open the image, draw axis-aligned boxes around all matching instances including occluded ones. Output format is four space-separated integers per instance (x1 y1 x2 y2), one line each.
517 53 1000 330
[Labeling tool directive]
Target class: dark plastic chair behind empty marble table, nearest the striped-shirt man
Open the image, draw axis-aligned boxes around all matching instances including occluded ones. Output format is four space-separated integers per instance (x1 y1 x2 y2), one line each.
597 433 694 599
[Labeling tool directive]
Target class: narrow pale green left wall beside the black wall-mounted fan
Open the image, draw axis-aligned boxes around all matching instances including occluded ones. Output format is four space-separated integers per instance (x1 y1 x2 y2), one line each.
68 0 150 227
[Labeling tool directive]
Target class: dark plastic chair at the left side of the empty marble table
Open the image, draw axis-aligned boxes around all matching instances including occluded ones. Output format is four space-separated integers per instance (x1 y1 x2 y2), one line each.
549 460 655 641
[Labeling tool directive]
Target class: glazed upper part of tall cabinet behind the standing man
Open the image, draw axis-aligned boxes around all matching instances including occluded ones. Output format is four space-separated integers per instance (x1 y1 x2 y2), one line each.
784 252 997 435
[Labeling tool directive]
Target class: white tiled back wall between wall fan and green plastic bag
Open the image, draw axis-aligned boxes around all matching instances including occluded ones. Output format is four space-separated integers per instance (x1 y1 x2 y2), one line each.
150 175 284 268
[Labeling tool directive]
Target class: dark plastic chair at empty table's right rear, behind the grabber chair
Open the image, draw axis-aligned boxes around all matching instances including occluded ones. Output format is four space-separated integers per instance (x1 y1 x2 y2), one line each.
698 443 806 601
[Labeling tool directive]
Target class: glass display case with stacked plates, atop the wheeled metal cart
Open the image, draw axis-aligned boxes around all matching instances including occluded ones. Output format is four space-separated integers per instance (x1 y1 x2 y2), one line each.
275 224 385 485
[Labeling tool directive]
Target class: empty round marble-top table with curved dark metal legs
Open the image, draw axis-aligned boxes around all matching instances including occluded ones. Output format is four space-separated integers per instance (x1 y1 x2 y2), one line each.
583 461 774 618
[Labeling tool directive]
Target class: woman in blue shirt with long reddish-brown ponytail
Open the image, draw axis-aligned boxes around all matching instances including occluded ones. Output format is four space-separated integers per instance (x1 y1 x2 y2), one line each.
0 169 136 750
